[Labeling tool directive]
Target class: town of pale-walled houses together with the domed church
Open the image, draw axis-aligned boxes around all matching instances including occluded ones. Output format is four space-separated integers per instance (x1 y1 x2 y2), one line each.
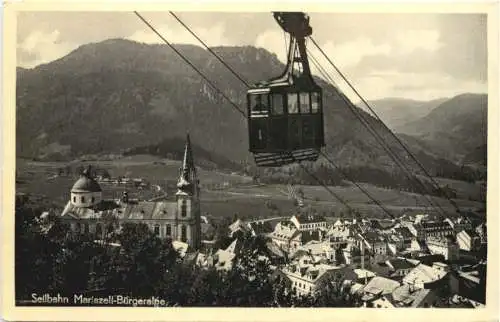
17 136 487 308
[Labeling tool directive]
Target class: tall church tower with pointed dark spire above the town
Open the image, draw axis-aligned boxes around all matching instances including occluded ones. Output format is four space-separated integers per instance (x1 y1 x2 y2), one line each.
176 134 201 250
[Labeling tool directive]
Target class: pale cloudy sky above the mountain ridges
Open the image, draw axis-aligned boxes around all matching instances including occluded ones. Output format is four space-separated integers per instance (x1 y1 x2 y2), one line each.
17 12 487 102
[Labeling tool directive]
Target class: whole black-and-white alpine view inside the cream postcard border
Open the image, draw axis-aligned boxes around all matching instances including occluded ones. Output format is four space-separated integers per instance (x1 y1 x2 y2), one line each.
3 1 498 311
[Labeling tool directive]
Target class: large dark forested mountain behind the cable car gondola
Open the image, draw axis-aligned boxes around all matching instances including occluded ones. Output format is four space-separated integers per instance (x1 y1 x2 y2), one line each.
16 39 476 182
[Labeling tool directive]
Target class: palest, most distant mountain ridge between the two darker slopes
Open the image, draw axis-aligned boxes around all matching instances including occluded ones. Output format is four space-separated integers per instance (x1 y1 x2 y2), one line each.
356 98 447 129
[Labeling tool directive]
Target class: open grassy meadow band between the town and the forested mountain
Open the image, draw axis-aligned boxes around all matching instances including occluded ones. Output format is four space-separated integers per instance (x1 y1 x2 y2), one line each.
16 156 484 218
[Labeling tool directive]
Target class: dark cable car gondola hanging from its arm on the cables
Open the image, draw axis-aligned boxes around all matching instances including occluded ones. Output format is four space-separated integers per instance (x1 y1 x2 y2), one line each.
247 12 325 167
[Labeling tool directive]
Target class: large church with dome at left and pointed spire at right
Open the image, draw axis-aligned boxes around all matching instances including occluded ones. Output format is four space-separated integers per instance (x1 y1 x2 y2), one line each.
61 135 201 249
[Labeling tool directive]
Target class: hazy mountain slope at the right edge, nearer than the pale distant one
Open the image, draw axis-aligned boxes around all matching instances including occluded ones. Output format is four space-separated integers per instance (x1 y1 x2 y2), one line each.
396 94 488 164
